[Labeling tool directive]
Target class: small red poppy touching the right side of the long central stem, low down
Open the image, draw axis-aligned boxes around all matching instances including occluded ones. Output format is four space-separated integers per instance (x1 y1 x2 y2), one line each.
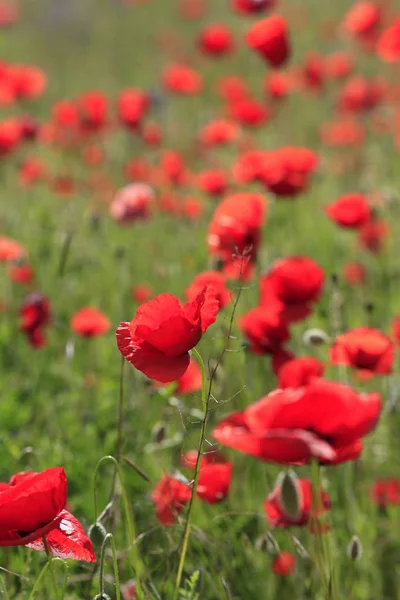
197 462 233 504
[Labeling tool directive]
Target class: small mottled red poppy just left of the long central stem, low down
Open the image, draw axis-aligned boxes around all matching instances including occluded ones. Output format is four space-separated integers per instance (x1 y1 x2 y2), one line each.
151 475 192 527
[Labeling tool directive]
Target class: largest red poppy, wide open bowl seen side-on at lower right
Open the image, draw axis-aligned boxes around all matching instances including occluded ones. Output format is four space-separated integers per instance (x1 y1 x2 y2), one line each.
213 379 382 464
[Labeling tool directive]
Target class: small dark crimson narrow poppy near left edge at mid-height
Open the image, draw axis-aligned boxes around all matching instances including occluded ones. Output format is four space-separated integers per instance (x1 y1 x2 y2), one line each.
20 292 51 348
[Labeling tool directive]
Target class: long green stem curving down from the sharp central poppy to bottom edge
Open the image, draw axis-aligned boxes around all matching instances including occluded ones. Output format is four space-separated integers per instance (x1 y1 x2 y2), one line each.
173 348 210 600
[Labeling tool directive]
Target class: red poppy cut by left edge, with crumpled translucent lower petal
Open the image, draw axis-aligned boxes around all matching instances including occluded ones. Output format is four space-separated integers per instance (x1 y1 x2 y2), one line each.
0 467 96 562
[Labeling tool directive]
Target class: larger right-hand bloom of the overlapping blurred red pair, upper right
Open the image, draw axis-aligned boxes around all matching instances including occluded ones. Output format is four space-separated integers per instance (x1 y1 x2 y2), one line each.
260 146 318 197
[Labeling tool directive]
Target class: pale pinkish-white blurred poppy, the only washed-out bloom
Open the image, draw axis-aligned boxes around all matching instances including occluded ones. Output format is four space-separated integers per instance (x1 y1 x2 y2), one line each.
110 183 154 224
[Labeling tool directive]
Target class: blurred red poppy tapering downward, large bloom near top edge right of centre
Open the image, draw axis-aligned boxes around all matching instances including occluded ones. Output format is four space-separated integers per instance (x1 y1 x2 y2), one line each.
246 15 290 67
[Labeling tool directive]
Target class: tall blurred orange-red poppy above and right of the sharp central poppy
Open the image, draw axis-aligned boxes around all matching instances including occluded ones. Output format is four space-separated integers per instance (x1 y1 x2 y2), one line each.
207 192 267 279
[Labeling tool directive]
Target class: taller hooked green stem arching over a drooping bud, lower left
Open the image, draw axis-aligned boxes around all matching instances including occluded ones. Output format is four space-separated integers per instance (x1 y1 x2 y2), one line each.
93 456 144 600
